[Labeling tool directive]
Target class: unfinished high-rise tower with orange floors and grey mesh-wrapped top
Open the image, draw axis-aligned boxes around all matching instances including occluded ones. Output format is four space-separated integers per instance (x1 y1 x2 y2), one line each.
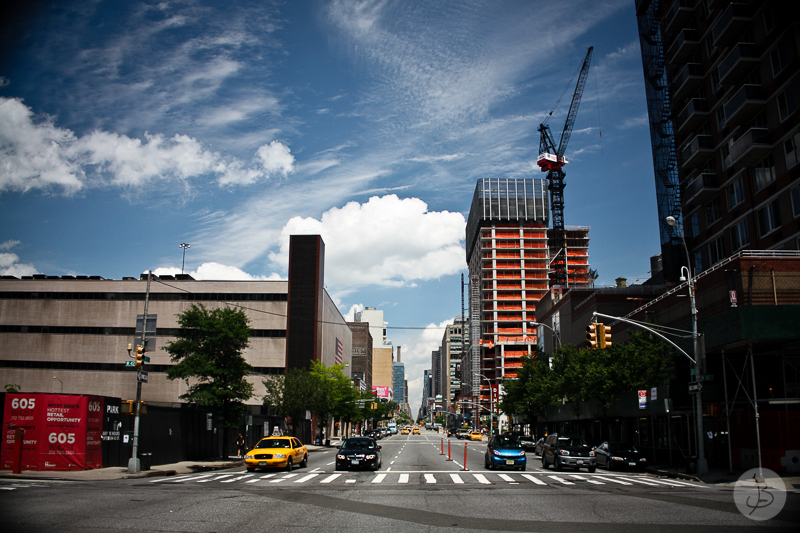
462 178 550 422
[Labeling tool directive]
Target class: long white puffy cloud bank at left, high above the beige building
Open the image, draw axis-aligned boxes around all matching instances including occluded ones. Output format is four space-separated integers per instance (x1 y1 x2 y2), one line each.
0 98 295 195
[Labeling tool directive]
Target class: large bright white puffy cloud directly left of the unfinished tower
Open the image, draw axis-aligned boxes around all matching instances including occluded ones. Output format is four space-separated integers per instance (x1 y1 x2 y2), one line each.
270 194 466 289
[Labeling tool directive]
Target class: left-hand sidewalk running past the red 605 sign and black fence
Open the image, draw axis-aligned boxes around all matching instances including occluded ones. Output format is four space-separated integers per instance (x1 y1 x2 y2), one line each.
0 442 334 481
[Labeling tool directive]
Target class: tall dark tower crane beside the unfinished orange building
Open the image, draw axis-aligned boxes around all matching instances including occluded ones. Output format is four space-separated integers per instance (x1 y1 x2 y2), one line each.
536 46 594 285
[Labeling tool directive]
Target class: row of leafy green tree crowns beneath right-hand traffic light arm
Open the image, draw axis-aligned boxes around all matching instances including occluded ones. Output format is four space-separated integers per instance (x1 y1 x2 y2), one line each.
500 332 674 421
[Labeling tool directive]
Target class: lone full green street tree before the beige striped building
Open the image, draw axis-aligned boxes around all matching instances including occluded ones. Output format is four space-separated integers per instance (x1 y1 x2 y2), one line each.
164 304 253 457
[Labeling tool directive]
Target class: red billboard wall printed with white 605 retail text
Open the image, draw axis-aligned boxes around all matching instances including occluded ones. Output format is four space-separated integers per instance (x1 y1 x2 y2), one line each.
0 393 104 470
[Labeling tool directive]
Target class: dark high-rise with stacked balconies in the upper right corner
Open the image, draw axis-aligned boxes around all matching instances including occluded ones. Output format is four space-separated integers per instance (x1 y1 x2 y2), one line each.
636 0 800 271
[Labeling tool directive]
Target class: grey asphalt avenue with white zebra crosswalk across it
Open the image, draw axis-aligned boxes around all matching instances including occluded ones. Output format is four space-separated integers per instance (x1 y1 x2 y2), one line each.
0 431 800 533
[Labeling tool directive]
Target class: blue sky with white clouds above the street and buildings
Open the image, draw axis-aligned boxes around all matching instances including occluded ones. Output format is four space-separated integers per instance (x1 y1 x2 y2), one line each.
0 0 660 416
